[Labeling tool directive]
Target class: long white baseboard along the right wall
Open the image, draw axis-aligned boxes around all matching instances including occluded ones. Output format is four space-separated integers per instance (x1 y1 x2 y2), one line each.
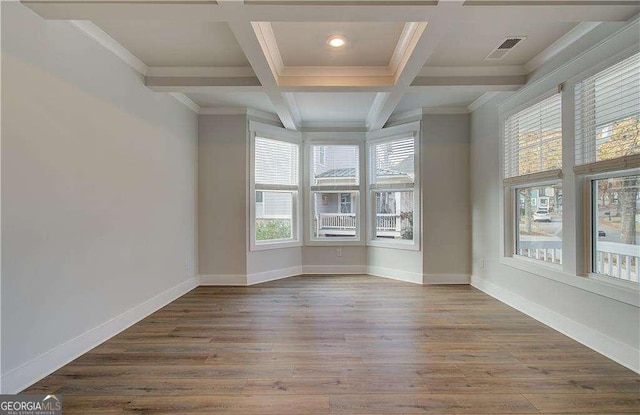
471 275 640 373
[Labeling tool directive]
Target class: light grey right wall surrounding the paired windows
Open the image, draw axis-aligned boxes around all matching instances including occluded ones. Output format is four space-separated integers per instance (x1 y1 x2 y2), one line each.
471 20 640 371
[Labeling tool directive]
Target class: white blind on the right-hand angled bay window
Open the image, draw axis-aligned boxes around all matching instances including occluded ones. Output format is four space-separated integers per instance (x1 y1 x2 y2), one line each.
369 137 415 185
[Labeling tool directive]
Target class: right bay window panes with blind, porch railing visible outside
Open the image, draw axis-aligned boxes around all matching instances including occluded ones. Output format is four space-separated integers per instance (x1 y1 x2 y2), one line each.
368 136 419 246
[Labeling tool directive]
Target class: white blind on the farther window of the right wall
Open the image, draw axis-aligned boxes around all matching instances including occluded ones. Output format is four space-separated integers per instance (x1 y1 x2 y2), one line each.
504 94 562 179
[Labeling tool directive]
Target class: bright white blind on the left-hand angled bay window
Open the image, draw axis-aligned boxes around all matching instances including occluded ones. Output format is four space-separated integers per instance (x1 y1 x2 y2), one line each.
255 137 300 187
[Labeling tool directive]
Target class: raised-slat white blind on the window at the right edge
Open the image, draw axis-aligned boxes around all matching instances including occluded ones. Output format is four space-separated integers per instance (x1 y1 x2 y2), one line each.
575 54 640 173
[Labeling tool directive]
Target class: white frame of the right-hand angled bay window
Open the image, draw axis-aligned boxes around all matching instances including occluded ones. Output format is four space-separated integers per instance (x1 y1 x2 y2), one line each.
365 121 422 251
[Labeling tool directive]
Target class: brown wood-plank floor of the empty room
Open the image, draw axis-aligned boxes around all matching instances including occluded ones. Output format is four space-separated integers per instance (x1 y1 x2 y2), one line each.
27 276 640 415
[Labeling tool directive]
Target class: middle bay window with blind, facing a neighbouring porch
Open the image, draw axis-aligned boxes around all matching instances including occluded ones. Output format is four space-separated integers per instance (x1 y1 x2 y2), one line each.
309 144 360 241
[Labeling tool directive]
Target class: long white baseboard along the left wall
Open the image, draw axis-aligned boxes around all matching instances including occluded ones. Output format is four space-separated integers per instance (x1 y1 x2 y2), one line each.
2 278 198 394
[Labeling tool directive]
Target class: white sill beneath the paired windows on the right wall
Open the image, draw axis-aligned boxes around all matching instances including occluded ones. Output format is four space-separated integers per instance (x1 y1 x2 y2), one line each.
500 257 640 307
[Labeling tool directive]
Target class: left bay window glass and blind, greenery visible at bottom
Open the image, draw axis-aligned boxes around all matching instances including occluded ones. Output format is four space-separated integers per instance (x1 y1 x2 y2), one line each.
252 137 300 249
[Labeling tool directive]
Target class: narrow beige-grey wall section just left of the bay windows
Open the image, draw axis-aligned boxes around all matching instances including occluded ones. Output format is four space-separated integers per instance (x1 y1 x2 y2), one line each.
198 115 248 283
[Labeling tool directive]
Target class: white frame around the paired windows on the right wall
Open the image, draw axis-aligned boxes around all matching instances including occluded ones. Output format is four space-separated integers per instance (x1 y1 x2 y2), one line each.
496 45 640 307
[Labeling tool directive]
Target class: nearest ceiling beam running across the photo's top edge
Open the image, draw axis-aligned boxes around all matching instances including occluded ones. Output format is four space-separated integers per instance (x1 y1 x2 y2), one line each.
23 0 637 24
